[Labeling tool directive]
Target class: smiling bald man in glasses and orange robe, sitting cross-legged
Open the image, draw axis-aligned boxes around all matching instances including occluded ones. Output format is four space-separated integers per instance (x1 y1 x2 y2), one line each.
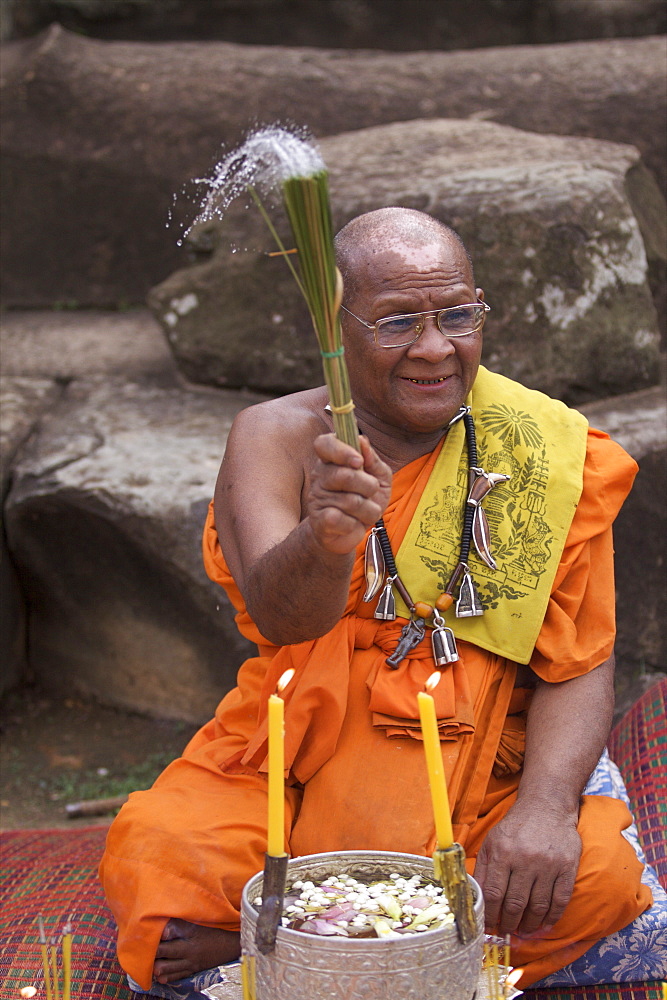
101 208 651 991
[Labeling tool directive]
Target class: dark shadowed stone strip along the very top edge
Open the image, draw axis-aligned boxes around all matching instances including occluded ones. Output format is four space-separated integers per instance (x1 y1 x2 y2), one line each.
0 0 665 52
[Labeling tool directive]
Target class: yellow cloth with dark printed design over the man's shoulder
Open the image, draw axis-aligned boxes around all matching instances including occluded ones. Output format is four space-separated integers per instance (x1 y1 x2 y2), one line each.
397 368 588 663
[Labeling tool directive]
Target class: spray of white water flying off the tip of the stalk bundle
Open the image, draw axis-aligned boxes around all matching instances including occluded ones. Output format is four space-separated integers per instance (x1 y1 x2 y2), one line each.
179 125 326 245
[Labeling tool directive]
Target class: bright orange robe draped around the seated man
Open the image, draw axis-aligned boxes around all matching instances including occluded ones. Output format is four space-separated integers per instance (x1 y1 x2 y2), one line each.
100 431 651 989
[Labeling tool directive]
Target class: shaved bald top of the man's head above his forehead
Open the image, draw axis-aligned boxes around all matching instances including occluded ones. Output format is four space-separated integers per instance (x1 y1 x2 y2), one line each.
334 207 474 299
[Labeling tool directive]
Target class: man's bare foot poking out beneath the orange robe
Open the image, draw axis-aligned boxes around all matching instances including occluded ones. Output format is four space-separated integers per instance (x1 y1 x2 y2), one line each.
153 919 241 984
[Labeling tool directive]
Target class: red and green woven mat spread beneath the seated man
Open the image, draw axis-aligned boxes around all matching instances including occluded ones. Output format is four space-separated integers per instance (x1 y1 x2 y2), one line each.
0 681 667 1000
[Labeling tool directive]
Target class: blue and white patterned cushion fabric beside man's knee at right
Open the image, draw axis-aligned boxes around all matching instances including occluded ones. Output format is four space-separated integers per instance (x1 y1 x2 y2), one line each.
534 750 667 987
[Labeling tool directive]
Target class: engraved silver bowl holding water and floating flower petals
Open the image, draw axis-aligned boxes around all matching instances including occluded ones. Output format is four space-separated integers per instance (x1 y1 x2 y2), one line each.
241 851 484 1000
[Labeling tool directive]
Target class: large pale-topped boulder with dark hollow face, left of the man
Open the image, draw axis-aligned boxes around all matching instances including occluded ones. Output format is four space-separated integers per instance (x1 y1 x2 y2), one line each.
6 376 268 721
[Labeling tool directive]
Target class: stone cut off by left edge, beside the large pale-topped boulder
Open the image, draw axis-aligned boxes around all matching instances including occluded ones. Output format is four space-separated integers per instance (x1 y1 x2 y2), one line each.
0 375 61 694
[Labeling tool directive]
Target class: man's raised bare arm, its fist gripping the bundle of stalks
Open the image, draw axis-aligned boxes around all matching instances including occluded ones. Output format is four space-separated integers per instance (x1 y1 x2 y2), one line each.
214 407 391 645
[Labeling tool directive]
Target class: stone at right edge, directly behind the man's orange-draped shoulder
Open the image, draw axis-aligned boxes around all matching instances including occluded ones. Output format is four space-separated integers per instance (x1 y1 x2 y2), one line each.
582 386 667 715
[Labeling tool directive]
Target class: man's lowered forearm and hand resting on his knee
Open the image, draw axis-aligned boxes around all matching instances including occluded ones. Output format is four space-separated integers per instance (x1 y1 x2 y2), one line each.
475 656 614 934
